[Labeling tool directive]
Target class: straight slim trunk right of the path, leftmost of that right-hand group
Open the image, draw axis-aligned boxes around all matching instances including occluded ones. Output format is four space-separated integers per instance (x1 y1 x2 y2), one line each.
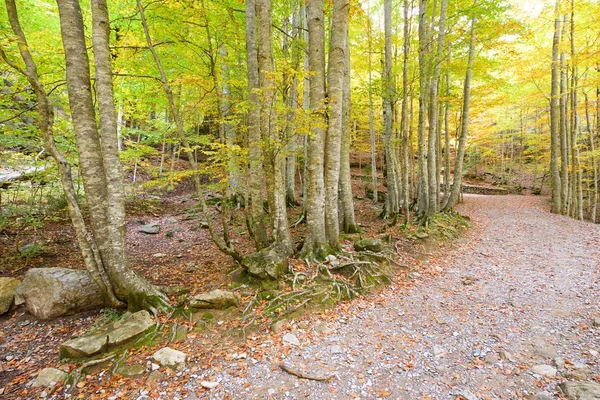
550 0 562 214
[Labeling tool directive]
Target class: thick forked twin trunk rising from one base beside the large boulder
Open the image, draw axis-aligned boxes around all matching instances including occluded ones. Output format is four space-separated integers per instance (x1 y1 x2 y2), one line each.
57 0 168 310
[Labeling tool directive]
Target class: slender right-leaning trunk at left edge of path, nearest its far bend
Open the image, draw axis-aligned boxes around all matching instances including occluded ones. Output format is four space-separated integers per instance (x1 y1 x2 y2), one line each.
444 19 476 210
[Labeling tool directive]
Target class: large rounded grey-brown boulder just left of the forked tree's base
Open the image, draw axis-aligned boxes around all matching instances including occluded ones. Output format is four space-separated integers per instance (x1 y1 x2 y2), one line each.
17 268 105 319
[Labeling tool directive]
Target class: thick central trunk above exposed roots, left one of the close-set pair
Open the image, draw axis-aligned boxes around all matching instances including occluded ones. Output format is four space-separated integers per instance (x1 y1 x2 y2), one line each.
301 0 328 259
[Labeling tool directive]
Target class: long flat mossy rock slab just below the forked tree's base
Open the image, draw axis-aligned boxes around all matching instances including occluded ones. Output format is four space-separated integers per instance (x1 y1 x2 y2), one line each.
60 311 154 358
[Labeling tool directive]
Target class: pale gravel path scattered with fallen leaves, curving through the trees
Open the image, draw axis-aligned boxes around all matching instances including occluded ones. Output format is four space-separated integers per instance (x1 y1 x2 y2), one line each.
202 195 600 400
